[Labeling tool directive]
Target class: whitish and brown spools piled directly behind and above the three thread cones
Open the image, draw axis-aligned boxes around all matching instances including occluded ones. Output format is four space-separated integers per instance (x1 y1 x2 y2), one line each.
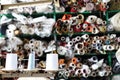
0 37 56 58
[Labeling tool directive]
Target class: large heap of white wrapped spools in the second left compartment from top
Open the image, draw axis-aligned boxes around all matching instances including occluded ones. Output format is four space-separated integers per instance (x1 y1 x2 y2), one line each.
0 13 55 38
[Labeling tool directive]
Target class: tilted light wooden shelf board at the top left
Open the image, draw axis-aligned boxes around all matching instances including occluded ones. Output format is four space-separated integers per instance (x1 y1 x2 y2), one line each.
1 0 51 10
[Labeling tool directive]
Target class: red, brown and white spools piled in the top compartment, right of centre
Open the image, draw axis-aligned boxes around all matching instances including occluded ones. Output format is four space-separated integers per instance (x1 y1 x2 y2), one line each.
54 0 110 12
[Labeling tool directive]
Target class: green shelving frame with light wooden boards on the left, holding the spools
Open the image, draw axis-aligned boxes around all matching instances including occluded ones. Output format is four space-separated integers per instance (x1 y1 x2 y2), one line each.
0 0 120 78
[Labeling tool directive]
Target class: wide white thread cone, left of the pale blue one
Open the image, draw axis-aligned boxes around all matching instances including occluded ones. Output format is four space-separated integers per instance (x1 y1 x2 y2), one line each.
5 53 18 70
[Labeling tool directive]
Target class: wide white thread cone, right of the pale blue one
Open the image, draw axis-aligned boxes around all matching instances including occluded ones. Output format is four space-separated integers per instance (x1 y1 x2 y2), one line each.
46 54 58 71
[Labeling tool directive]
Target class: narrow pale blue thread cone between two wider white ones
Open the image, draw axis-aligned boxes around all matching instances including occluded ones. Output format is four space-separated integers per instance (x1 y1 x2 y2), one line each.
27 52 35 70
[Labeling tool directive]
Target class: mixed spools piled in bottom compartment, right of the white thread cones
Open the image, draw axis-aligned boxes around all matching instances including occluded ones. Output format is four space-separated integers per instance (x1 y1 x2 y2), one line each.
57 56 112 79
